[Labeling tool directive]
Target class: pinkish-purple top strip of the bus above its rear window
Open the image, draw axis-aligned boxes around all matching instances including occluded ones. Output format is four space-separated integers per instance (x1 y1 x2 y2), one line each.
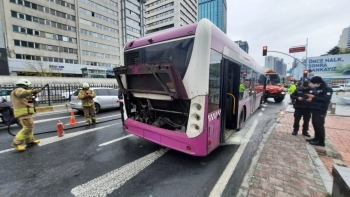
124 23 198 51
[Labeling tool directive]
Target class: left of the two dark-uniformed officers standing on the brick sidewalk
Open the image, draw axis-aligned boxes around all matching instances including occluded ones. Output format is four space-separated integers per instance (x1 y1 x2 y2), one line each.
291 80 314 137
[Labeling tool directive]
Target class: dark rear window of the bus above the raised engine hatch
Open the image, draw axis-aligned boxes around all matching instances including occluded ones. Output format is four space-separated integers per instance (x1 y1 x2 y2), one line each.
125 38 194 79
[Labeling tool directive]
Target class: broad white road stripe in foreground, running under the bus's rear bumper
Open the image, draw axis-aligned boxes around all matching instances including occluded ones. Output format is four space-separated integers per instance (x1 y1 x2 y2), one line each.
71 149 169 196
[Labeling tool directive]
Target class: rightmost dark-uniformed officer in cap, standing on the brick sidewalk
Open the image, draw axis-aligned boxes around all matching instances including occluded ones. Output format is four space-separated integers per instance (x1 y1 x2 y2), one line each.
306 76 333 146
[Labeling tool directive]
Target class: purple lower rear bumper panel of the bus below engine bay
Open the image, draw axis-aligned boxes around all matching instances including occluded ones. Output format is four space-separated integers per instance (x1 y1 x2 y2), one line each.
125 118 208 156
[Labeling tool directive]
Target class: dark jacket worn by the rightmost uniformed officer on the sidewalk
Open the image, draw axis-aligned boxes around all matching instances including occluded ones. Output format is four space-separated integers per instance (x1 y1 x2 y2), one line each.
311 83 333 111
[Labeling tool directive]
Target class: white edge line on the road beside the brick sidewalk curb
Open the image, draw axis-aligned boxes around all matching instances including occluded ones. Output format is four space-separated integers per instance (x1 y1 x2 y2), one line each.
209 119 258 197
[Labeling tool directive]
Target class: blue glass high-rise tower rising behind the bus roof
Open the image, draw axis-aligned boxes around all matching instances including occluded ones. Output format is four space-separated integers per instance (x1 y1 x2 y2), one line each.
198 0 227 33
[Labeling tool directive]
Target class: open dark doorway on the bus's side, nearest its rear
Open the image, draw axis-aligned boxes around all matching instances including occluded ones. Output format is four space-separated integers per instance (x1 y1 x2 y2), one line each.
220 59 240 142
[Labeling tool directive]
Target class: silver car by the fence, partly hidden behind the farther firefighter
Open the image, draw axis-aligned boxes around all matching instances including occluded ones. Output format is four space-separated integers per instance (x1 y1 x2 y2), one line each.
70 88 119 113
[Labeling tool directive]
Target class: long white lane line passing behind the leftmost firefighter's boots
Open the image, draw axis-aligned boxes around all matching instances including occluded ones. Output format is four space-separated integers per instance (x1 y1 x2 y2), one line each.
0 123 121 154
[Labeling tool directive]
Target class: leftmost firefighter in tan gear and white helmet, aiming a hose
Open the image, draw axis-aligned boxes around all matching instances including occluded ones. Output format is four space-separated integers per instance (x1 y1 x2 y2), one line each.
11 79 42 151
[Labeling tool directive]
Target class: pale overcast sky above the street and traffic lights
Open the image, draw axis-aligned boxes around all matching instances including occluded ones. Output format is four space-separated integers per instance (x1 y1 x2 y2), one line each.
227 0 350 68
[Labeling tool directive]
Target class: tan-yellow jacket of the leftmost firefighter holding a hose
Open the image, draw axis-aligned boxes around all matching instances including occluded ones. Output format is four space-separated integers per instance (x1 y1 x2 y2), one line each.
11 88 35 118
